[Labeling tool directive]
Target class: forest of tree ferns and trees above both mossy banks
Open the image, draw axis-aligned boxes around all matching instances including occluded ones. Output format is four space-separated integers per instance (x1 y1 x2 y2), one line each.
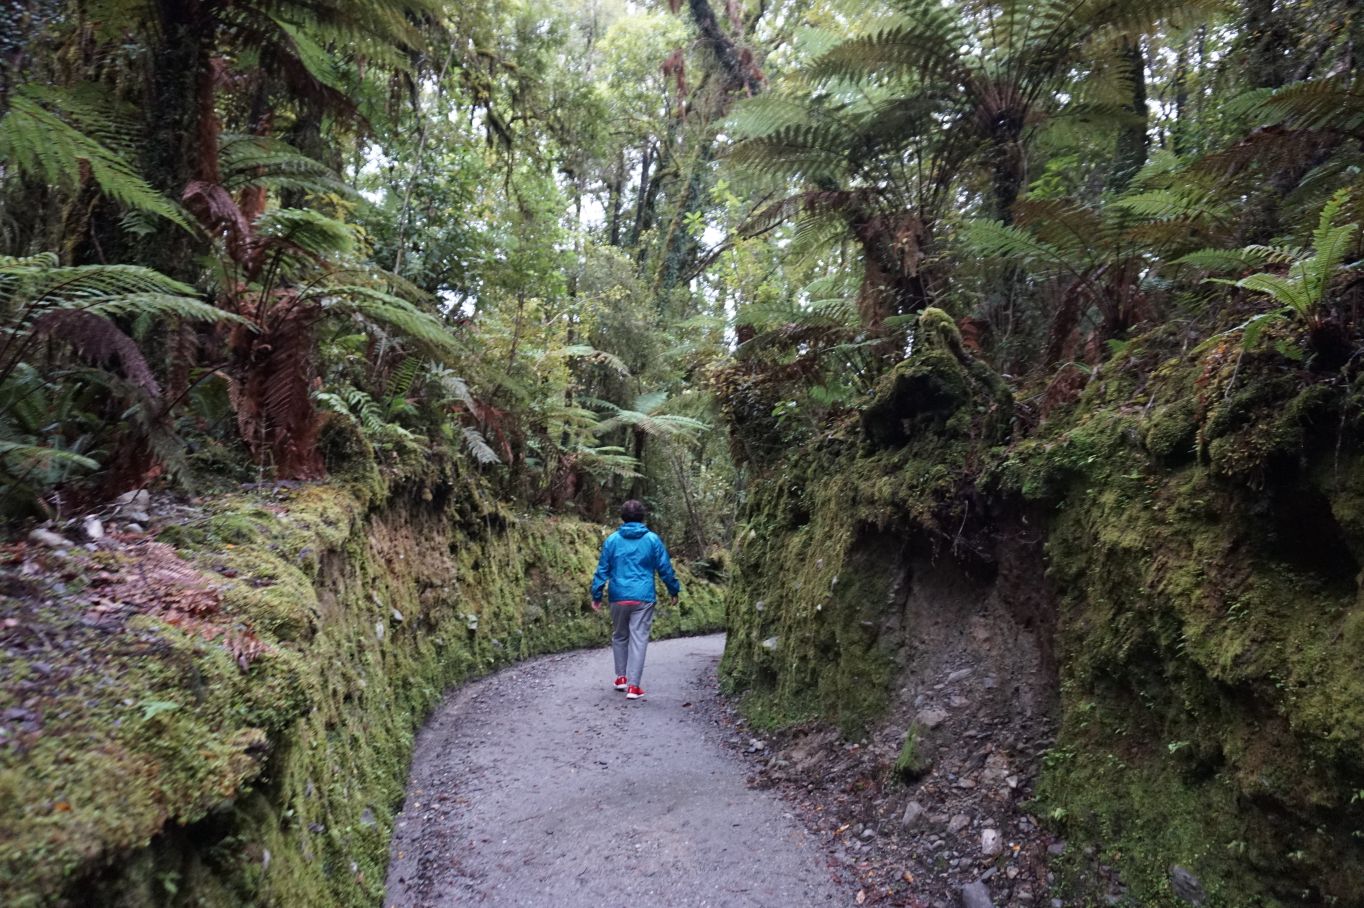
0 0 1364 554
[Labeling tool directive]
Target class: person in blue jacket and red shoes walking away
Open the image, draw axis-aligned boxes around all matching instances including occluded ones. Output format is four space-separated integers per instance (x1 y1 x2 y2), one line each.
592 499 681 699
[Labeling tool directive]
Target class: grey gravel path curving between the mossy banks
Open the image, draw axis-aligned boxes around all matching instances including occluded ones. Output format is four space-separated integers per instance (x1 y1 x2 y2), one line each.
386 635 853 908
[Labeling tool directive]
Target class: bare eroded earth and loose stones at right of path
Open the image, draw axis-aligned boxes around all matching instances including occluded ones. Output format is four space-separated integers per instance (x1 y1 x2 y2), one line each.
708 550 1123 908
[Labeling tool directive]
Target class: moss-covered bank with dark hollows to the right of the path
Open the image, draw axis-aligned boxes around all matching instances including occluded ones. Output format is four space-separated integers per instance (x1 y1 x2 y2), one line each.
723 309 1364 907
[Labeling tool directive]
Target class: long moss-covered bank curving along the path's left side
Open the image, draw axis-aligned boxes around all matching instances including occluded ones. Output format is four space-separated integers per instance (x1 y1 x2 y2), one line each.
0 463 720 908
